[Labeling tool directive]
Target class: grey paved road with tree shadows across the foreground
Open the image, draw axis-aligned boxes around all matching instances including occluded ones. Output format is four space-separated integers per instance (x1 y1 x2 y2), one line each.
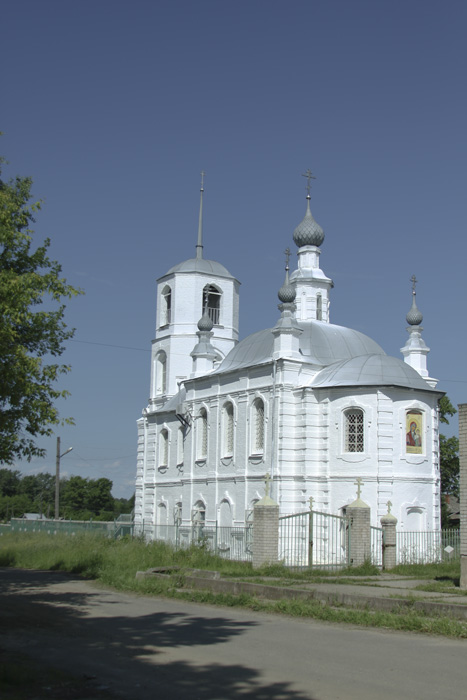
0 569 467 700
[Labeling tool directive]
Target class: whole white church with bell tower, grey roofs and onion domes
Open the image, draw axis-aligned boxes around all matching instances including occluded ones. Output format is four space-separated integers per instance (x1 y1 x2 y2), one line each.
135 171 442 531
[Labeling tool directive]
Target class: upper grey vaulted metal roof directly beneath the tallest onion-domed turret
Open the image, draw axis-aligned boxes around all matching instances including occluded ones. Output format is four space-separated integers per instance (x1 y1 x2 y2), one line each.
216 321 385 373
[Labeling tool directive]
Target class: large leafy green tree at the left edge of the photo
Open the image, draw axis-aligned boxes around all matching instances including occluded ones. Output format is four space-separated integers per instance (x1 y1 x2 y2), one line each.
0 159 81 464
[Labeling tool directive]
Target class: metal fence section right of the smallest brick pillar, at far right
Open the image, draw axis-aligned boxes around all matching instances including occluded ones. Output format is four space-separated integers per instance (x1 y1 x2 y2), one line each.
396 530 460 564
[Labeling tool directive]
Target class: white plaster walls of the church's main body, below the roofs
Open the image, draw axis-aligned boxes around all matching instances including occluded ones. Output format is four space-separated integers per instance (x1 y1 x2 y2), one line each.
135 361 439 529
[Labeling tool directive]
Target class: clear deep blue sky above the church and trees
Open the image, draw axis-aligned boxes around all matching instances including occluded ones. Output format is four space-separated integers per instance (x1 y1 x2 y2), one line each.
0 0 467 497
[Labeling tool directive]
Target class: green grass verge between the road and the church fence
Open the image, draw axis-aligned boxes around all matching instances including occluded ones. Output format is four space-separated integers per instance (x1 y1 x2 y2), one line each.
0 533 467 638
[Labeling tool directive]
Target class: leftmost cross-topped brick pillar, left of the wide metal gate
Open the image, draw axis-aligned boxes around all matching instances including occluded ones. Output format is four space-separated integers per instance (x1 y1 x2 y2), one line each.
253 496 279 569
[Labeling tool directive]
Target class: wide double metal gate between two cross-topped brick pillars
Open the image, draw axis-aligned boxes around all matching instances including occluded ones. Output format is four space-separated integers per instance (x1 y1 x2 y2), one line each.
279 511 350 568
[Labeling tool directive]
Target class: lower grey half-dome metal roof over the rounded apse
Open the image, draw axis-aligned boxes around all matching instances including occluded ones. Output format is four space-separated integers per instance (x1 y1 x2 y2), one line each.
310 354 433 391
